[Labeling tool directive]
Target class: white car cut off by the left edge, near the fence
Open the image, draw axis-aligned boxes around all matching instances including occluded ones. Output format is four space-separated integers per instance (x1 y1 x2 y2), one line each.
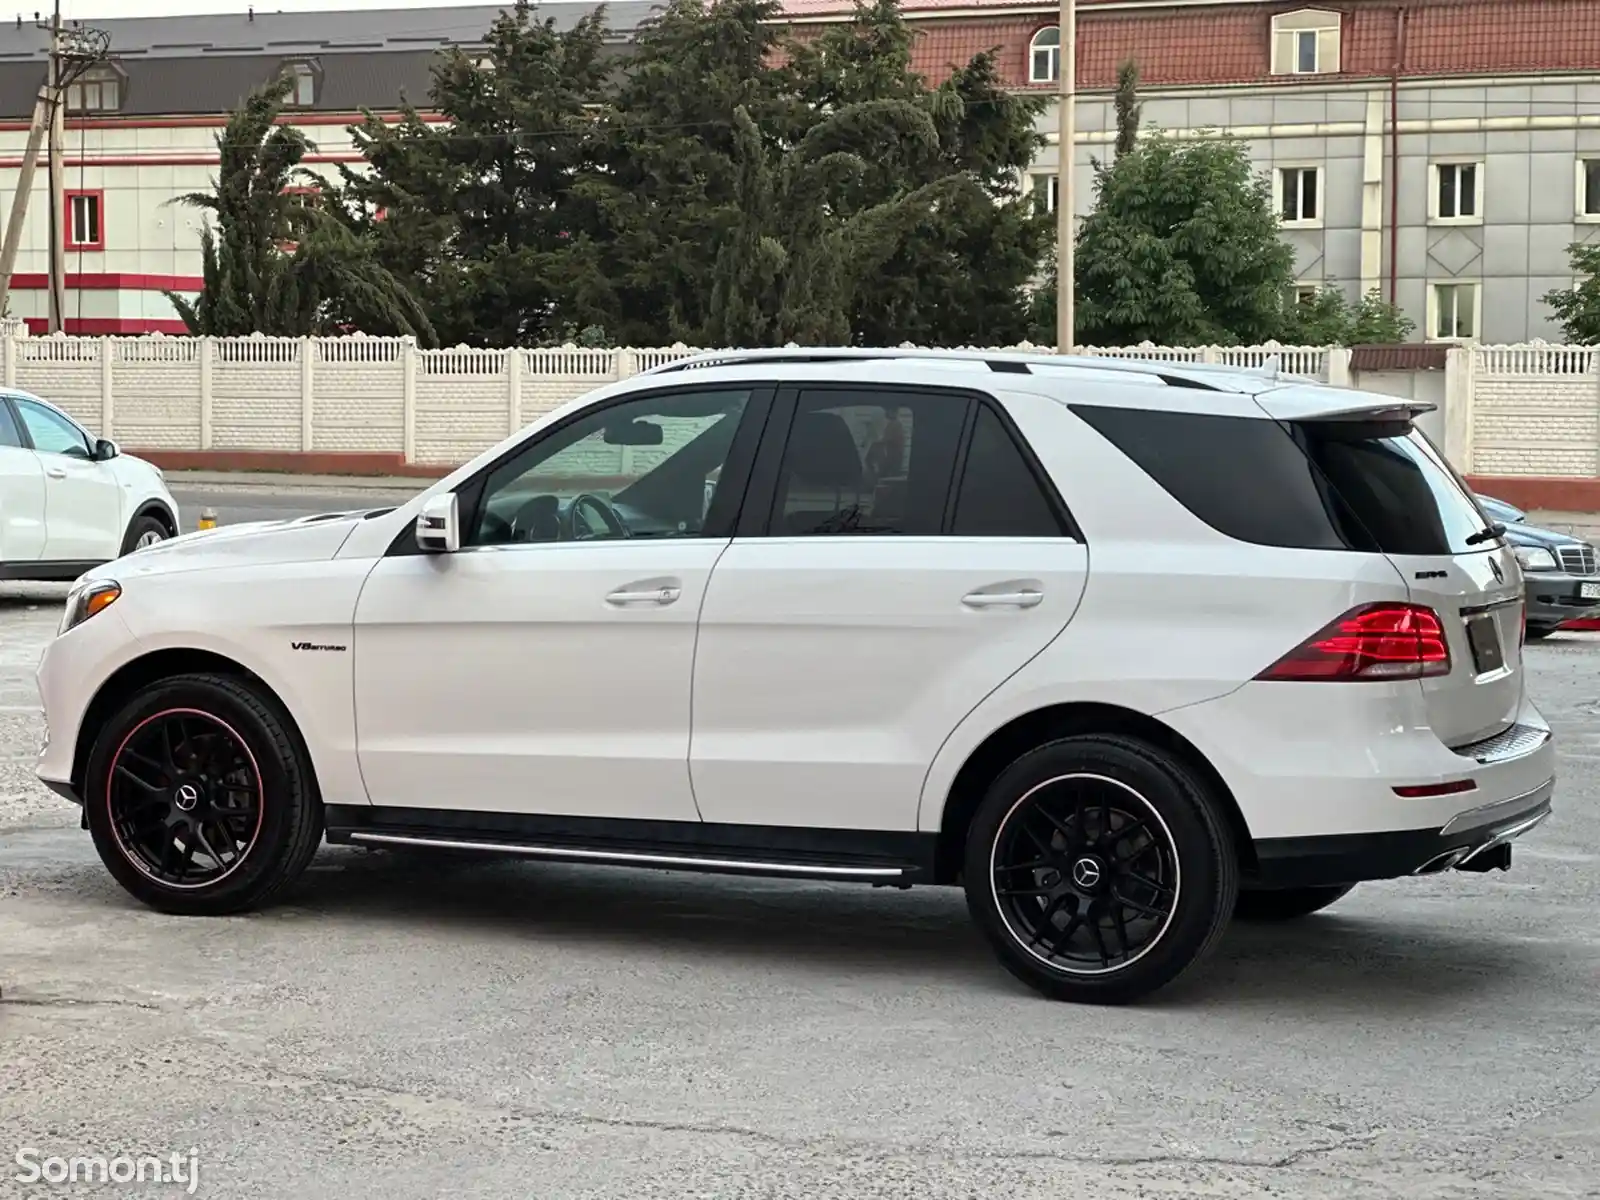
0 390 178 581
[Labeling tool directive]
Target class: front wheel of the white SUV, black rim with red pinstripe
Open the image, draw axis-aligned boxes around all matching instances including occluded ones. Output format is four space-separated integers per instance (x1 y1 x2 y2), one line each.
83 675 323 915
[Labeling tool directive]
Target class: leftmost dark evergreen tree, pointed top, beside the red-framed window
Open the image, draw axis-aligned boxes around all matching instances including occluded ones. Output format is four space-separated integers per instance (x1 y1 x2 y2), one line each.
166 75 432 341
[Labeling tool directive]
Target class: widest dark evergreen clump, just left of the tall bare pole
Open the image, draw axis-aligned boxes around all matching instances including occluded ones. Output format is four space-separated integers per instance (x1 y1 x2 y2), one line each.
589 0 1048 344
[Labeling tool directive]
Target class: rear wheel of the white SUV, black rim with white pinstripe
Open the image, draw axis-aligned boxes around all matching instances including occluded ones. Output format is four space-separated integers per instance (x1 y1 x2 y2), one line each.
963 734 1238 1005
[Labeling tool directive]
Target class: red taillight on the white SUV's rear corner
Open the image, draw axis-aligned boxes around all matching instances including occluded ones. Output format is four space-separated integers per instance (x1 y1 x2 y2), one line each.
1256 605 1450 682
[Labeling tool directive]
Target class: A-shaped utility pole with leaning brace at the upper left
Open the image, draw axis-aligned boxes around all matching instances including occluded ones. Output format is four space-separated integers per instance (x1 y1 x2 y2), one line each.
0 0 110 330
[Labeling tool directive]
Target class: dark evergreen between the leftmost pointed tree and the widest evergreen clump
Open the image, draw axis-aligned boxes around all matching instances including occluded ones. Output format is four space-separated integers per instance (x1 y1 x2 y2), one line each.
341 0 610 346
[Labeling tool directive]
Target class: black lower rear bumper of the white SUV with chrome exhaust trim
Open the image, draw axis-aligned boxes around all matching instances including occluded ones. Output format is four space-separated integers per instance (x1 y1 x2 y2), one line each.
1246 779 1555 888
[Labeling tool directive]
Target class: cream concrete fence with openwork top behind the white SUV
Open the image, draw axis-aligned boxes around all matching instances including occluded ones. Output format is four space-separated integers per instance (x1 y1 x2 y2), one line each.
0 334 1600 509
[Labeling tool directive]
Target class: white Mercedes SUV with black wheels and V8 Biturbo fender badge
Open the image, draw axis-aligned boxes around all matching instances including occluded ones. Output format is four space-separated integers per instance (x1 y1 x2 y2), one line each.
38 350 1555 1002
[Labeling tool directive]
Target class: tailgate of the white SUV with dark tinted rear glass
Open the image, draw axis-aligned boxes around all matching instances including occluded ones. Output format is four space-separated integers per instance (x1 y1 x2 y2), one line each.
1264 405 1523 746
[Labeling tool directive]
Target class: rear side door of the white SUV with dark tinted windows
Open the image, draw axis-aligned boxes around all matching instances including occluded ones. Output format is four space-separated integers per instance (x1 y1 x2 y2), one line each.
690 386 1088 830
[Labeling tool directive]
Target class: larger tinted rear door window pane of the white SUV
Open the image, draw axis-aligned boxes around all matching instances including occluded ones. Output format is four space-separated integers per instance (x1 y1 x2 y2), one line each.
770 387 971 538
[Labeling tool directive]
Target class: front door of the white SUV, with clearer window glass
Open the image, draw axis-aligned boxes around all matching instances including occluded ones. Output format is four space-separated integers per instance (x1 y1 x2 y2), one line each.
354 387 766 821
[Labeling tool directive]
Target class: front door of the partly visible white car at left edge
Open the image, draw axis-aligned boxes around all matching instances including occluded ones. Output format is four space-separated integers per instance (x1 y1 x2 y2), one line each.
14 397 123 563
